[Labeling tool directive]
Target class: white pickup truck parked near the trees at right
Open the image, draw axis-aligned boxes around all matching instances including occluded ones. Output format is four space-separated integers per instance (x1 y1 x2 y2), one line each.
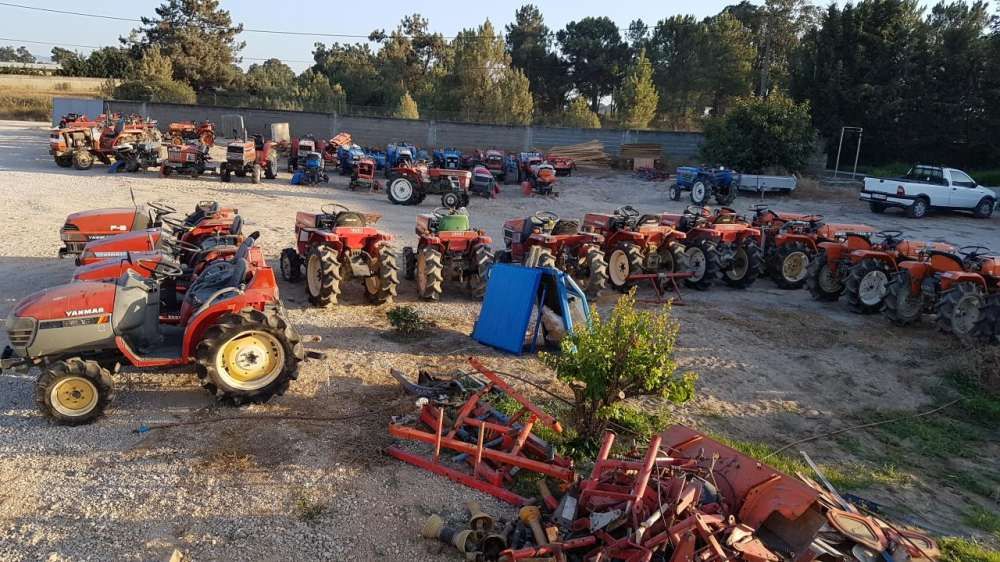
860 164 997 219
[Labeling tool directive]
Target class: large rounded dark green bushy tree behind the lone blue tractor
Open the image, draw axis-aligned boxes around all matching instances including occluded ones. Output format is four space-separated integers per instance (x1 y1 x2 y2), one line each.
701 92 816 173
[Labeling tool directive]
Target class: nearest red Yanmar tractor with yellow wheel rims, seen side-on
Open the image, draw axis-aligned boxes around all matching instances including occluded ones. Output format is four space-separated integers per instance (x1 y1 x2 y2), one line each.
0 235 305 425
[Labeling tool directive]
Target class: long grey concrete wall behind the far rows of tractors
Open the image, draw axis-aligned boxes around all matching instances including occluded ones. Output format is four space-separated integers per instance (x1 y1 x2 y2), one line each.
107 100 703 159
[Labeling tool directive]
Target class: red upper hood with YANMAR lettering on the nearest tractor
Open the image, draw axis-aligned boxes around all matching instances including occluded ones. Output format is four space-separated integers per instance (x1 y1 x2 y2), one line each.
12 281 116 322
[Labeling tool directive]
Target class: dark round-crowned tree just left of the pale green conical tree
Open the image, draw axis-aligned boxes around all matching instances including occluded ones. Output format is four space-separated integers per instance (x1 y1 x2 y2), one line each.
556 17 628 112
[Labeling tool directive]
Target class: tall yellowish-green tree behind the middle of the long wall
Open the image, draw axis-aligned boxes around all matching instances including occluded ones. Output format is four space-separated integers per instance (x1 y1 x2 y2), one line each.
446 20 534 125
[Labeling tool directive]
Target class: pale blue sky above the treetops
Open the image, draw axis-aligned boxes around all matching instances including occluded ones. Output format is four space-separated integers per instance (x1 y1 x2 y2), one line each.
0 0 936 71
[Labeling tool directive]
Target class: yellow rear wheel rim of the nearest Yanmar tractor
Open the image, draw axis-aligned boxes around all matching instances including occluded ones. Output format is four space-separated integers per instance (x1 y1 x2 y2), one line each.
216 331 285 390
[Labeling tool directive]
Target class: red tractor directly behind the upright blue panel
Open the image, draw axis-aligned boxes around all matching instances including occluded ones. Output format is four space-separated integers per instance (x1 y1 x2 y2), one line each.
497 211 608 295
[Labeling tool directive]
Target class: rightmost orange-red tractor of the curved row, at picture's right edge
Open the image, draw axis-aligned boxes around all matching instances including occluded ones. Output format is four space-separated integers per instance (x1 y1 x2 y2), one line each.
885 246 1000 340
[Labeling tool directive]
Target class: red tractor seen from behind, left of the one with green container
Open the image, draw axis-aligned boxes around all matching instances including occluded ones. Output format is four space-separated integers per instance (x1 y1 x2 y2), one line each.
281 203 399 306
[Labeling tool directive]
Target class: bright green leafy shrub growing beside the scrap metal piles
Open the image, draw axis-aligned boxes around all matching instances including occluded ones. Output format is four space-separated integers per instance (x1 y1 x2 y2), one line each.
541 290 697 437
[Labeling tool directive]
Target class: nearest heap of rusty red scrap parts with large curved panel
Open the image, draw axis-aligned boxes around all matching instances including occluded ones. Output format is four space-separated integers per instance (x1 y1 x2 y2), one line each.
394 402 939 562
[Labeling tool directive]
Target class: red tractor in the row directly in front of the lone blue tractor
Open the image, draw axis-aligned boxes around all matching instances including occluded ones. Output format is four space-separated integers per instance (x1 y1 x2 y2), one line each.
660 205 763 291
